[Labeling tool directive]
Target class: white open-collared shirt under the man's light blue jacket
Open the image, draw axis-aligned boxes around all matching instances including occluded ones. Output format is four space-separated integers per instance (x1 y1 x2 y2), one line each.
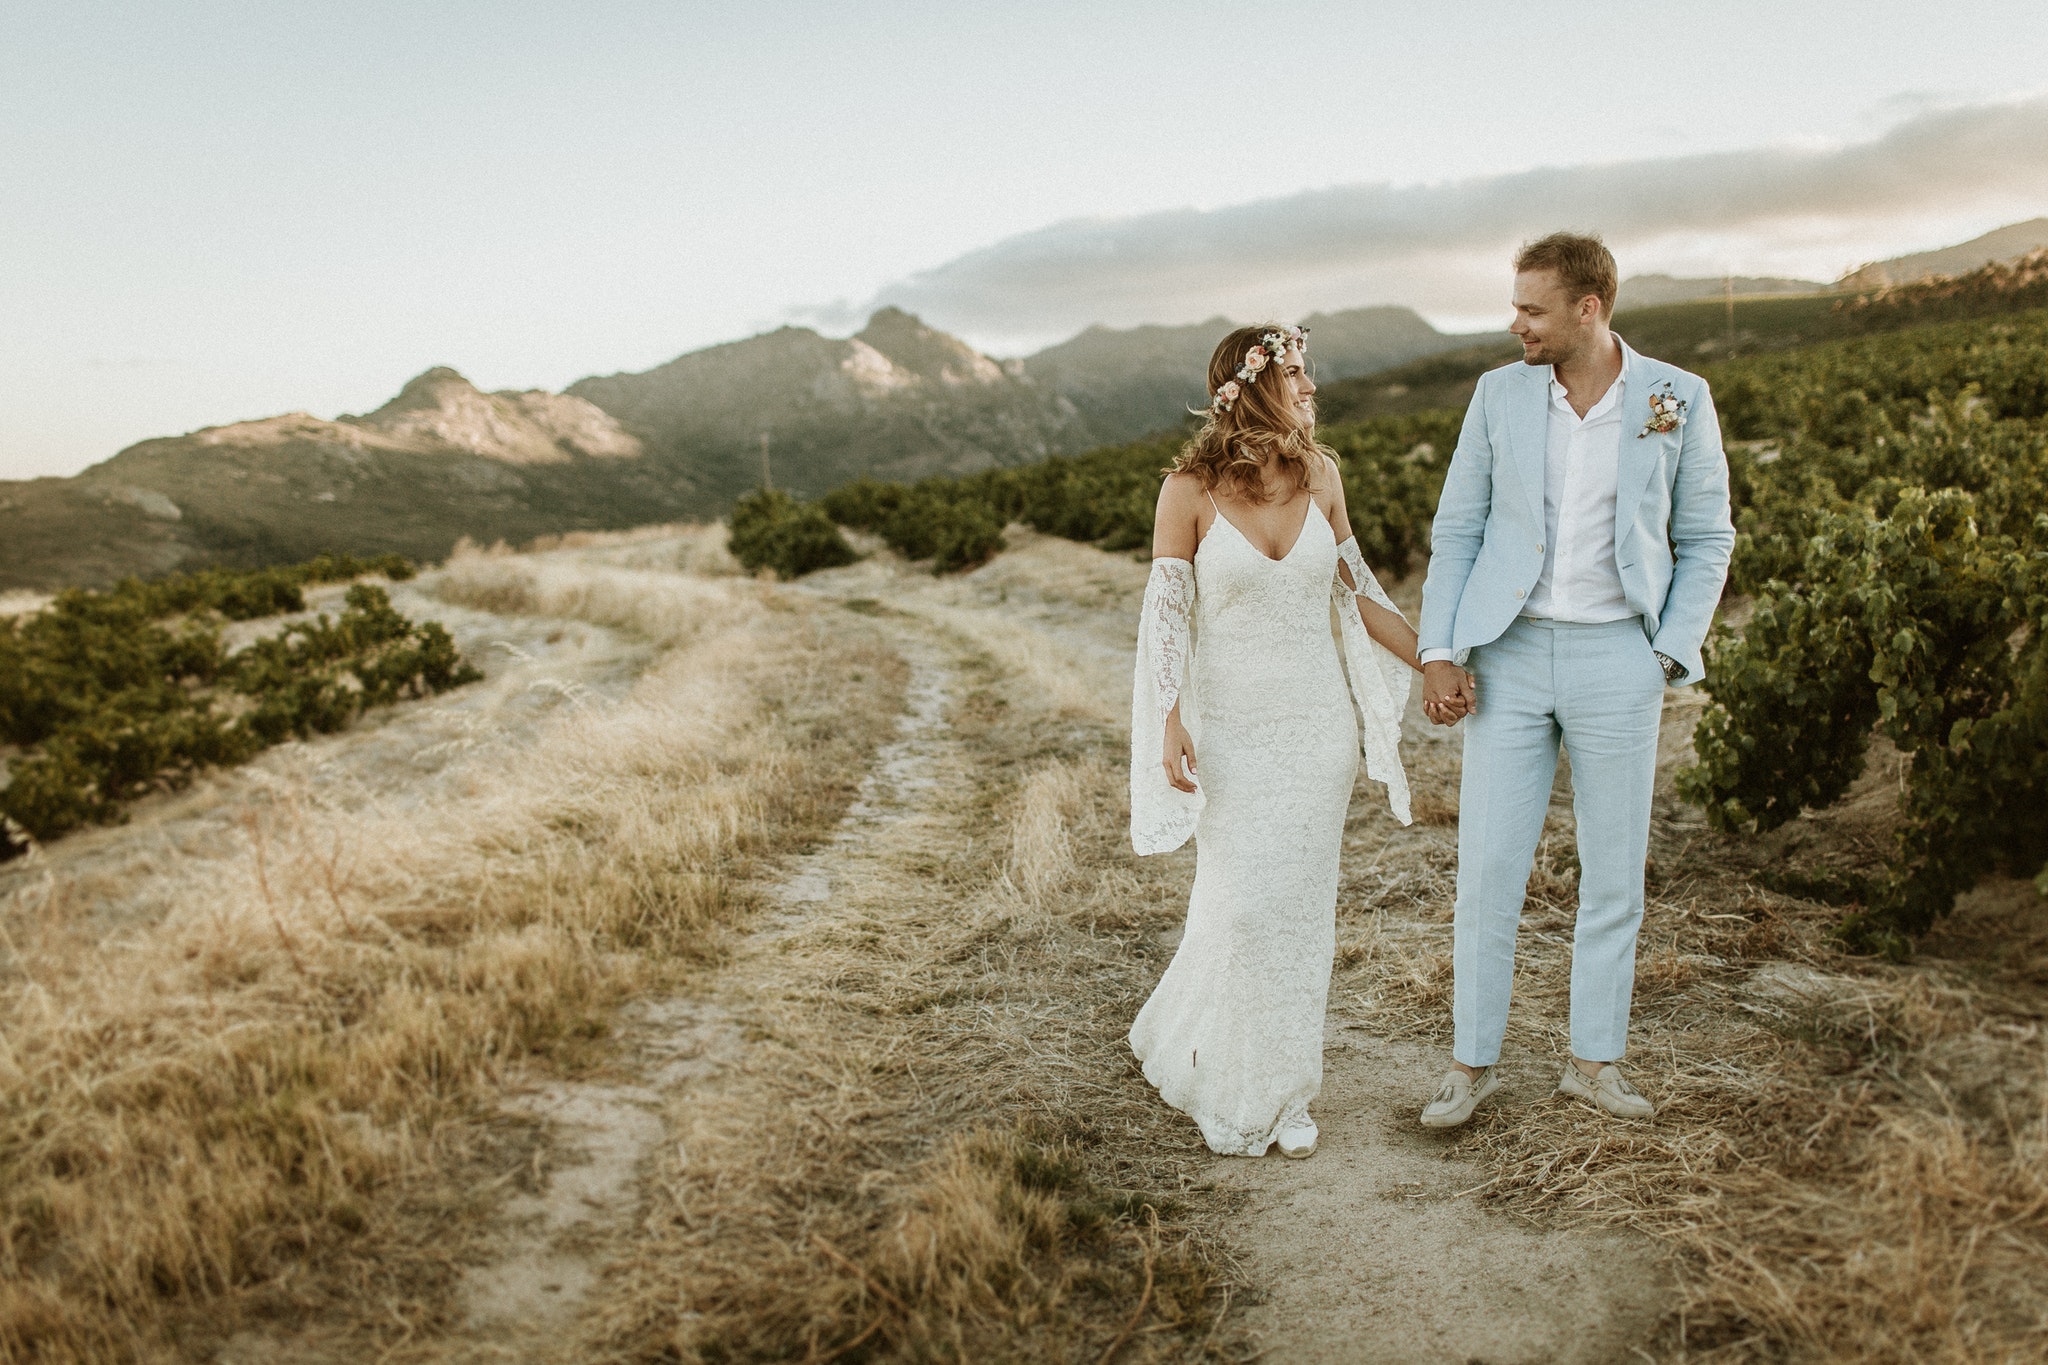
1419 346 1636 663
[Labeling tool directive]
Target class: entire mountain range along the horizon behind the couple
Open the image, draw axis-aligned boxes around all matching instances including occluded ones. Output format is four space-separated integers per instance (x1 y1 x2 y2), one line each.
24 219 2048 589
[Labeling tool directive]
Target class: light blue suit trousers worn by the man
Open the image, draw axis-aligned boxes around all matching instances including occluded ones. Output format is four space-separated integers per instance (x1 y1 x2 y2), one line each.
1452 616 1665 1066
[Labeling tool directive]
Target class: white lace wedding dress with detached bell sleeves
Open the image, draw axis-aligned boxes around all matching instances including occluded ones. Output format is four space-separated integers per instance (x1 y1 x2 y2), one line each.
1130 501 1411 1156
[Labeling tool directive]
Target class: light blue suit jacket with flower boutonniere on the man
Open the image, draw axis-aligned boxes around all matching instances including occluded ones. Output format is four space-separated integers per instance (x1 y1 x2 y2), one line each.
1421 342 1735 686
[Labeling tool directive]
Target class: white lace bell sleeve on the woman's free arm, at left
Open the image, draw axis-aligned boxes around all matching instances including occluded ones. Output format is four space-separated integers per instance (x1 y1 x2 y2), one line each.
1130 559 1204 853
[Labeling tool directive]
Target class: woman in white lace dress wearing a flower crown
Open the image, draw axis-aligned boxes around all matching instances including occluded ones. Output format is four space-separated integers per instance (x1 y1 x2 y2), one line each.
1130 325 1421 1156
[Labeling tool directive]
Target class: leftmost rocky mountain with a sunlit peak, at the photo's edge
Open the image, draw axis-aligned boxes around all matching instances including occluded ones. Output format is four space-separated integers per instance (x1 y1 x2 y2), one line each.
0 368 686 587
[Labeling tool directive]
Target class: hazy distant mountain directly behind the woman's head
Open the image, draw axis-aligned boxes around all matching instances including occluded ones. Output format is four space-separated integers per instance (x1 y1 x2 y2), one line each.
1024 307 1477 442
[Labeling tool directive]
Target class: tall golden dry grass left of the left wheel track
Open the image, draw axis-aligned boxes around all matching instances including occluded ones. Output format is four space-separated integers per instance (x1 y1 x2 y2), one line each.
0 557 901 1361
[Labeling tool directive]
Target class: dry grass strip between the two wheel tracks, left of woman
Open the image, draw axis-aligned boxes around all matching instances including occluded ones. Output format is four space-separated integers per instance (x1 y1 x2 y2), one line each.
575 556 1235 1361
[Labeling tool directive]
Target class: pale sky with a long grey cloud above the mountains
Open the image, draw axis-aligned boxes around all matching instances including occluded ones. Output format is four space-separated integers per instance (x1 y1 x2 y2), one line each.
0 0 2048 477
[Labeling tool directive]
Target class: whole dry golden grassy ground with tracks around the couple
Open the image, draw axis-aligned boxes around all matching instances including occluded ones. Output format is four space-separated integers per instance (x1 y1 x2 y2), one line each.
0 528 2048 1365
